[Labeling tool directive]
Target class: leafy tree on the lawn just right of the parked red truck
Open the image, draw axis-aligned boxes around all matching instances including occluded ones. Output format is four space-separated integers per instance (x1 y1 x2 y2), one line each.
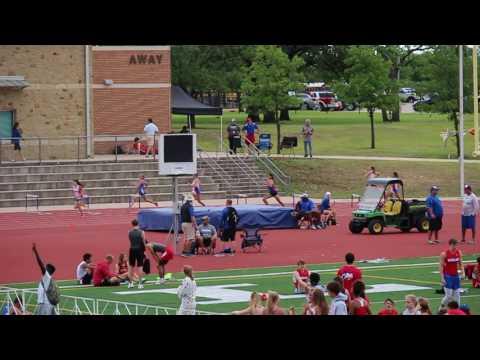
335 46 398 149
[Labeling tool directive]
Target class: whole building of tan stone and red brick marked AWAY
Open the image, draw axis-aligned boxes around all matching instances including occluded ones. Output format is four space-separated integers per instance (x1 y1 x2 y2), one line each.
0 45 171 159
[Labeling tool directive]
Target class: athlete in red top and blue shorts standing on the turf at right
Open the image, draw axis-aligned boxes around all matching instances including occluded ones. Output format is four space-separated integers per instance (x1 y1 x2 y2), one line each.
439 239 464 305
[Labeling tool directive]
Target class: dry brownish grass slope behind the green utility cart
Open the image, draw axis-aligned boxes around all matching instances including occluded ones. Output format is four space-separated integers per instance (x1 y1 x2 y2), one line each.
275 159 480 198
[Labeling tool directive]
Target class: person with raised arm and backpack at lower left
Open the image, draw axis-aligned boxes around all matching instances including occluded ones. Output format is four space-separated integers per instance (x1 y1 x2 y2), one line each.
32 243 60 315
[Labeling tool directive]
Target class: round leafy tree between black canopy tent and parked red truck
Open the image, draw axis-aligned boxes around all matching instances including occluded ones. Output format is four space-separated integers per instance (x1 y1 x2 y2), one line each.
241 45 304 154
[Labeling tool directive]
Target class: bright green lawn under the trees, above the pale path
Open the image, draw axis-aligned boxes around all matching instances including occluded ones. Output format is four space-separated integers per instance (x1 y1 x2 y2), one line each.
173 111 474 158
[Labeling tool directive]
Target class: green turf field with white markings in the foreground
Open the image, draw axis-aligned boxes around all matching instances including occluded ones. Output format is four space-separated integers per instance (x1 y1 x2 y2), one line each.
0 256 480 315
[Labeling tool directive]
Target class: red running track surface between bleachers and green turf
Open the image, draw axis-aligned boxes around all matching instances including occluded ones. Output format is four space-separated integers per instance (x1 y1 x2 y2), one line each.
0 202 480 283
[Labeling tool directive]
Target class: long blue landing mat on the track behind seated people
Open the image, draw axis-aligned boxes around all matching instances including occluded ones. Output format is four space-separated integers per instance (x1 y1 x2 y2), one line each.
138 205 297 231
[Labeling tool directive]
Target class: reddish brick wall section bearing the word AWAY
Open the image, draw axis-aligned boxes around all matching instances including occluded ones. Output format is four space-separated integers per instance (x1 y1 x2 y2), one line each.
92 48 171 154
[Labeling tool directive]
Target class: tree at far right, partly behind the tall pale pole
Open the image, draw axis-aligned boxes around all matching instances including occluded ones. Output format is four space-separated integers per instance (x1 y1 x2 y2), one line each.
414 45 473 156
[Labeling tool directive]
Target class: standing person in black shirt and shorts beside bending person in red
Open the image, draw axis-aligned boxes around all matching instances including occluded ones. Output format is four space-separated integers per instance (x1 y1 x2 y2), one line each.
126 219 145 289
